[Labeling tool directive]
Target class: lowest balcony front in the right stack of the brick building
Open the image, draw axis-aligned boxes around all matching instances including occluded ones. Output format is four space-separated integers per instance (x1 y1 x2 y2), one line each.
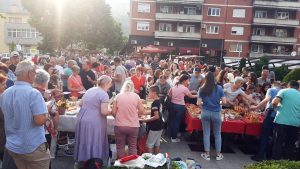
251 35 297 44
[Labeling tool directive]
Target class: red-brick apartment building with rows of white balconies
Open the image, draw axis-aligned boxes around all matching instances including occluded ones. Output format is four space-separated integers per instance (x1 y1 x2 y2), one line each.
129 0 300 58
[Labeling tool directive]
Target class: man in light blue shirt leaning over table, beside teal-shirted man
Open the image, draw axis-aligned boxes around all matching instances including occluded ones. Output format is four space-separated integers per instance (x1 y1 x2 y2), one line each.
250 81 281 161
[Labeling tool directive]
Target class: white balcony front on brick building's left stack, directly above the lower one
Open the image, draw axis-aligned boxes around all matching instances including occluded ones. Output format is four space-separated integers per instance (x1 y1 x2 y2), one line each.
156 13 203 22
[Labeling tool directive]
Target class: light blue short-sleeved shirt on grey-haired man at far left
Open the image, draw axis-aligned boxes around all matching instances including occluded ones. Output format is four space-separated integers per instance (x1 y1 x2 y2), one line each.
0 81 48 154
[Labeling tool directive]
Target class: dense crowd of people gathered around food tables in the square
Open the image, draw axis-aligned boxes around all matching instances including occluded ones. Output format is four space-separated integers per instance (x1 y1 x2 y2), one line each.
0 52 300 169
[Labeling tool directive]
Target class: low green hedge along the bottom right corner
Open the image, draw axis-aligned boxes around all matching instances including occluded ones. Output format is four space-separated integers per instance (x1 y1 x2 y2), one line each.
244 160 300 169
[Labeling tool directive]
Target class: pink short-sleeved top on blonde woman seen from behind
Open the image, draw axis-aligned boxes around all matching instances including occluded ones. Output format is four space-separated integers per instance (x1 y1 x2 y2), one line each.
115 92 140 127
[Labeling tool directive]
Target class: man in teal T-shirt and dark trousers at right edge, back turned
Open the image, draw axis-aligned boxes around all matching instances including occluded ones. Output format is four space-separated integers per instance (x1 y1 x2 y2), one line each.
272 80 300 160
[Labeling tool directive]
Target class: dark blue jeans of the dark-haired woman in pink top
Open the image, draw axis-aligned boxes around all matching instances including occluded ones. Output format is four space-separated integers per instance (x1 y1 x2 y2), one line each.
169 103 186 139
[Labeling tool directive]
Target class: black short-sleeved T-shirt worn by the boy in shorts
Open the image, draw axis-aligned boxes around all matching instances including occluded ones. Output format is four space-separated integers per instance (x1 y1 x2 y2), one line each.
147 100 164 131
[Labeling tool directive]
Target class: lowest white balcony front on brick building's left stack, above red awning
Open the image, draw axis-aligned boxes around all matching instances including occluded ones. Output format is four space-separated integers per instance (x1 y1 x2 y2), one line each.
155 31 201 40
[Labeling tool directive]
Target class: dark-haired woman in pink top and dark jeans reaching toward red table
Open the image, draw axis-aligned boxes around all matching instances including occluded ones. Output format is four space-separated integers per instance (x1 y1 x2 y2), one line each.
169 74 197 143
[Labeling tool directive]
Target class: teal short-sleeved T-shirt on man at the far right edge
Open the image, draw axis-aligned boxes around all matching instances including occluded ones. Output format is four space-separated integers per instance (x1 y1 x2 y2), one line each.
274 88 300 127
